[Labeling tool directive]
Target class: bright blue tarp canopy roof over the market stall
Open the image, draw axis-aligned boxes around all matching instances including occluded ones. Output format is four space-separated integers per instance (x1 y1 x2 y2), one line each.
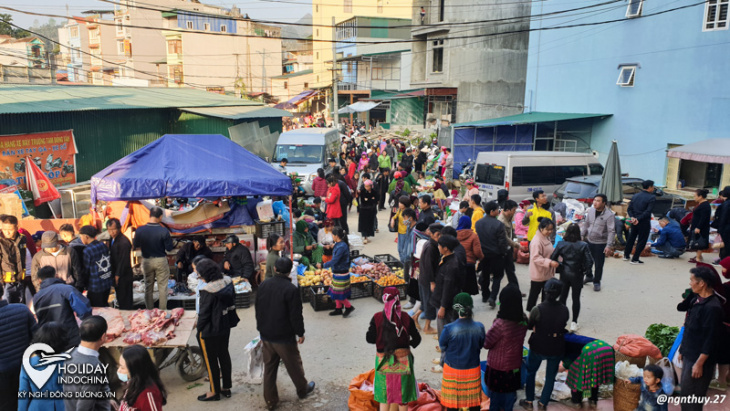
91 134 292 203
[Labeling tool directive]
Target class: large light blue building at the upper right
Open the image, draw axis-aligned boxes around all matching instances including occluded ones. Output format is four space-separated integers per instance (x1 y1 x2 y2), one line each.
525 0 730 188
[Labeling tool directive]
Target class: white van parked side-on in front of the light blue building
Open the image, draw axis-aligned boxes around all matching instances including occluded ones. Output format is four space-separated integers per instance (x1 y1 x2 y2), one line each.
474 151 603 202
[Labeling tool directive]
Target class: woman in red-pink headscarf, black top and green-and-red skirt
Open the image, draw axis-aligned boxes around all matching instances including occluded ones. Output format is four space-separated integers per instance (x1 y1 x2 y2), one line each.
365 287 421 411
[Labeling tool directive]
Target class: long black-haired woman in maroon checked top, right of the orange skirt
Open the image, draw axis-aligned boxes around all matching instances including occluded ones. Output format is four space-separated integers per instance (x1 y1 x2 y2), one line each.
484 284 527 411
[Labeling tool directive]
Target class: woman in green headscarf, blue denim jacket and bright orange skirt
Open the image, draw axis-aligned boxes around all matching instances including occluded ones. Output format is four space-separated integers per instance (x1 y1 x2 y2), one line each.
439 293 485 411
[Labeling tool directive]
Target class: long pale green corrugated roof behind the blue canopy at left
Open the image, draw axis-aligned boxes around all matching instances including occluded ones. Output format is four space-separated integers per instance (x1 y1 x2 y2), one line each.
0 84 262 114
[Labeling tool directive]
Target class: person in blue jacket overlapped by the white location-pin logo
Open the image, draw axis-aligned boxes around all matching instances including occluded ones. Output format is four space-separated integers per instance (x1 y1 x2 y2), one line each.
18 321 68 411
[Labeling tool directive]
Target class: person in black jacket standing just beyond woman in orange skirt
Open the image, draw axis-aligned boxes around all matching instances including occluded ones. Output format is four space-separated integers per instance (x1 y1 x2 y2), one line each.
430 235 460 335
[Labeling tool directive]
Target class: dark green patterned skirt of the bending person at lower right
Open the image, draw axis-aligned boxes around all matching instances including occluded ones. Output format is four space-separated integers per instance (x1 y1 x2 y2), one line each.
566 340 615 391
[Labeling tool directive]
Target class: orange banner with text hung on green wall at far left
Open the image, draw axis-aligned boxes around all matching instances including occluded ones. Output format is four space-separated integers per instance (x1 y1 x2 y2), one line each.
0 130 76 190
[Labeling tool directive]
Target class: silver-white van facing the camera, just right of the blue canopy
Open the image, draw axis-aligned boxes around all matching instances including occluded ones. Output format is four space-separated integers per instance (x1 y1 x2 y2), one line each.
271 127 342 195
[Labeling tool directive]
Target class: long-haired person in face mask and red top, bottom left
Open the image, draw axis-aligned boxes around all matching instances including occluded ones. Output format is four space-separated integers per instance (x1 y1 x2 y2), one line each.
117 344 167 411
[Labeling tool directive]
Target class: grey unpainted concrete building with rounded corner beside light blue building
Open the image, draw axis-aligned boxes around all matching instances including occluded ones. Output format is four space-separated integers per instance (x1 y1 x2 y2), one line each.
411 0 531 127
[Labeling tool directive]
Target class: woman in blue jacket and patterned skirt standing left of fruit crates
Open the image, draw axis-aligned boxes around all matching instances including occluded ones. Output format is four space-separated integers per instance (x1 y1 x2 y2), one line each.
317 227 355 318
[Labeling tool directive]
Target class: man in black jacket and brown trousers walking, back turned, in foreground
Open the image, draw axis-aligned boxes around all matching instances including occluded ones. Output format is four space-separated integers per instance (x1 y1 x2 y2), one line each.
256 257 314 410
